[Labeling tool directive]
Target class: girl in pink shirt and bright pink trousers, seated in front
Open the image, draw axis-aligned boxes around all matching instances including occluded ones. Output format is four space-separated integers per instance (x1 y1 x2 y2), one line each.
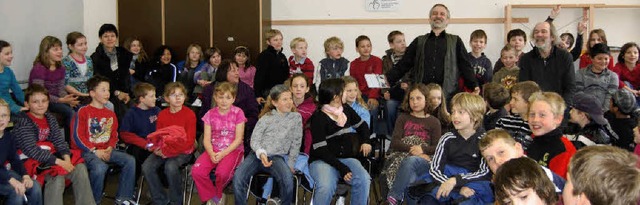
191 82 247 204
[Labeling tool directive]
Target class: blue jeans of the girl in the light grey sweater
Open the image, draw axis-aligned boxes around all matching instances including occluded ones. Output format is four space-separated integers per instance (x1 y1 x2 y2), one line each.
233 152 294 205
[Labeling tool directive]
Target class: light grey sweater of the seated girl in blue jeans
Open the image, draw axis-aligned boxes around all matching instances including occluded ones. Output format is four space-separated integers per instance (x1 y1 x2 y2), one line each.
251 109 302 167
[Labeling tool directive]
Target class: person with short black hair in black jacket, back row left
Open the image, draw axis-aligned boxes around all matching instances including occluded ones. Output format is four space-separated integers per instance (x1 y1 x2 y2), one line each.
91 24 133 119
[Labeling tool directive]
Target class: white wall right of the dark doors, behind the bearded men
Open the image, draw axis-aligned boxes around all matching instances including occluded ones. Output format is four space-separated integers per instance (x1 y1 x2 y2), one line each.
272 0 640 68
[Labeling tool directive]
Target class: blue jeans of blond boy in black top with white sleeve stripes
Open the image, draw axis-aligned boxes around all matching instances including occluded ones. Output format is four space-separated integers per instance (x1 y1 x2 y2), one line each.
420 165 494 204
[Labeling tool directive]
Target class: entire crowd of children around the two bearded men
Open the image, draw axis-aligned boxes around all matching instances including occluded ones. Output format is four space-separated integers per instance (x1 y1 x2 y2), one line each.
0 11 640 204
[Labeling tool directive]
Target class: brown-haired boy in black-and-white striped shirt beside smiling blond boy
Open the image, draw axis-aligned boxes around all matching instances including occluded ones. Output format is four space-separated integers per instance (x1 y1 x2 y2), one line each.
496 81 540 151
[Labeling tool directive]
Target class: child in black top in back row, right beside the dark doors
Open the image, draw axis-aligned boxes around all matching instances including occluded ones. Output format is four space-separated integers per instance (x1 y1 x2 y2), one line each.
253 29 289 103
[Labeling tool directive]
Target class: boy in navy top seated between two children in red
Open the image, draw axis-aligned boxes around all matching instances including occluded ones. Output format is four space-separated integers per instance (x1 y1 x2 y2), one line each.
120 83 160 179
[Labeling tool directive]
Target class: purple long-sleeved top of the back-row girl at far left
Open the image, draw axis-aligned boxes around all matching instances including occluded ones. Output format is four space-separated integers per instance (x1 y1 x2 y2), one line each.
29 63 67 103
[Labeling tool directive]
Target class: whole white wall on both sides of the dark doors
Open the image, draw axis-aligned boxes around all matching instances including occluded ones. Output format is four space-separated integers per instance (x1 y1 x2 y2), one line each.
0 0 640 80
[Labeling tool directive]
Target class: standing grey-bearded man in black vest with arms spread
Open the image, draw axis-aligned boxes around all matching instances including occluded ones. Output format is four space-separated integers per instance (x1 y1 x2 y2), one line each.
386 4 480 99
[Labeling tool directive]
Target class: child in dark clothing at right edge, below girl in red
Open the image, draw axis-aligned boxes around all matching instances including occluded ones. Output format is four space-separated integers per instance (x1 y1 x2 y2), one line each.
604 89 638 152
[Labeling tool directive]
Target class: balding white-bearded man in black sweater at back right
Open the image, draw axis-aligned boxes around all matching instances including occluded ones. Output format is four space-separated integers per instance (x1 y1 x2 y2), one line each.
518 22 576 105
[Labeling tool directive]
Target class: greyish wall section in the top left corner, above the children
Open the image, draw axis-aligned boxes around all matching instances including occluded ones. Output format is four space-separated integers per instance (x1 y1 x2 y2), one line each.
0 0 83 81
